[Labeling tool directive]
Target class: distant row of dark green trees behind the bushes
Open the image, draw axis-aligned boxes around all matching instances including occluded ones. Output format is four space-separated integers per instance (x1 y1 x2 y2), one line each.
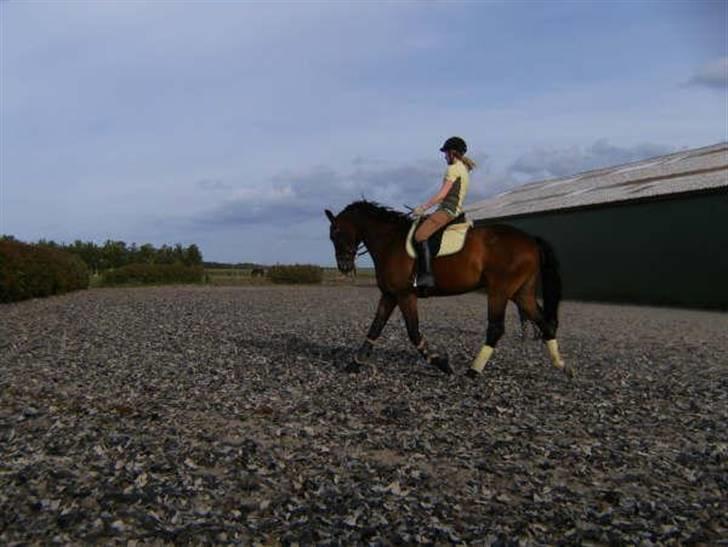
0 236 202 273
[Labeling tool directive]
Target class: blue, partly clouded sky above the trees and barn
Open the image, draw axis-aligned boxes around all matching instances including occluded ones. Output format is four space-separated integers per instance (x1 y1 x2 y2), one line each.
0 0 728 265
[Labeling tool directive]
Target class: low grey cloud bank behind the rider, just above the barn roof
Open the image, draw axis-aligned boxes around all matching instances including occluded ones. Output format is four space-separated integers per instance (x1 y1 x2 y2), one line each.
195 139 675 228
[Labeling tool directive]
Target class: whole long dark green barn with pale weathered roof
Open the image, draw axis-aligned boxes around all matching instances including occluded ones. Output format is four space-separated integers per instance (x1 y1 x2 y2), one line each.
467 142 728 310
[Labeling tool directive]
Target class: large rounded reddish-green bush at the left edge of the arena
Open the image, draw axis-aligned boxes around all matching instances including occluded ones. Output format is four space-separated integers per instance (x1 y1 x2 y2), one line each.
0 239 89 302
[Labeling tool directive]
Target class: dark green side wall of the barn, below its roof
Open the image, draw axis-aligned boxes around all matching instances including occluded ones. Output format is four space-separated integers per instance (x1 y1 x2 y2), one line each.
477 192 728 310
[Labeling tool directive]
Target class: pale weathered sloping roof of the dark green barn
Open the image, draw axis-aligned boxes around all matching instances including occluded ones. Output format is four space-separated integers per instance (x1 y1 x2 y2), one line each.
465 142 728 220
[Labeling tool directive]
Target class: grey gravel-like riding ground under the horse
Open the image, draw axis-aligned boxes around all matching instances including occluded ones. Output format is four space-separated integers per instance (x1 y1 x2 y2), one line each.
0 286 728 545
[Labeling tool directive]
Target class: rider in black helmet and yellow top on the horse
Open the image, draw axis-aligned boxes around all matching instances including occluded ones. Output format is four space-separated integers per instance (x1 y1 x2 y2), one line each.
413 137 475 289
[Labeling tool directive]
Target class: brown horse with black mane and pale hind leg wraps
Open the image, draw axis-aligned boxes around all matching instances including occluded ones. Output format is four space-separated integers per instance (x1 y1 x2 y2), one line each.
325 200 573 376
